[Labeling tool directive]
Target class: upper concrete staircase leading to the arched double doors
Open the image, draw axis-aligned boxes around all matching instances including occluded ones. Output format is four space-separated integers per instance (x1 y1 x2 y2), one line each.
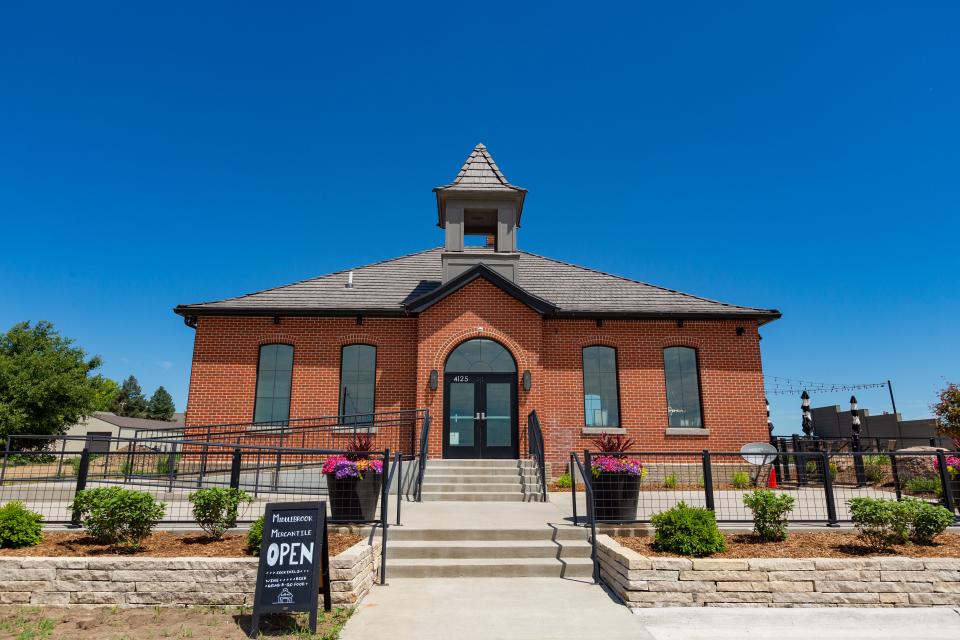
423 460 541 502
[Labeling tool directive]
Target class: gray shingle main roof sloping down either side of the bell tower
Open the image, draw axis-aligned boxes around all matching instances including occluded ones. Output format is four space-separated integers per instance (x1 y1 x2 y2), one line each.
174 248 780 322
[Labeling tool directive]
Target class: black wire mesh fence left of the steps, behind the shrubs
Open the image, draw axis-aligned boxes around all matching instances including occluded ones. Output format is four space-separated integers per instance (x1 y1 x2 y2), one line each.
0 436 402 523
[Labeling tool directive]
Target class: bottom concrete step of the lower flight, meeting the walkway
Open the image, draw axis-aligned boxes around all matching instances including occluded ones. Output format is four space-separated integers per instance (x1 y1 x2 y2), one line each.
387 556 593 580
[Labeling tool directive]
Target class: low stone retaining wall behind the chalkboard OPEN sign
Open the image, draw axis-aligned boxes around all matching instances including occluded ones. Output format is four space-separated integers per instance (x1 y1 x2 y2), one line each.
0 540 381 607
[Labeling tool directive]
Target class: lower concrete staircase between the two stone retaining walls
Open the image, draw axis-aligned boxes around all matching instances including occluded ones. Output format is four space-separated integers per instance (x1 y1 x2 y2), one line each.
387 525 593 578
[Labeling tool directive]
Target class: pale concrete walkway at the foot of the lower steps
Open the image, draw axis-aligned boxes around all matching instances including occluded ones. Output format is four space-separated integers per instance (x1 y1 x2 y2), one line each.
340 578 654 640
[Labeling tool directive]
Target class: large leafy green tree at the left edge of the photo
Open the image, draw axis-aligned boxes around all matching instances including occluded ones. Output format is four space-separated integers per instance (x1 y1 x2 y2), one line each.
0 321 101 449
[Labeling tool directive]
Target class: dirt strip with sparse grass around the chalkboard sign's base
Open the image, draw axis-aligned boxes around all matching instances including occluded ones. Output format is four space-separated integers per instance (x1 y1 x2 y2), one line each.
0 606 353 640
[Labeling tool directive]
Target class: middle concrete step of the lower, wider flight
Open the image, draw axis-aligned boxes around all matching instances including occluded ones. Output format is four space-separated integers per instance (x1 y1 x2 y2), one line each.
387 540 590 560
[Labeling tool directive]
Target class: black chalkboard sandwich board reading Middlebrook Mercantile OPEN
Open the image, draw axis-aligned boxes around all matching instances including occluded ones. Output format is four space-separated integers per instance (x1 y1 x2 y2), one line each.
250 502 331 637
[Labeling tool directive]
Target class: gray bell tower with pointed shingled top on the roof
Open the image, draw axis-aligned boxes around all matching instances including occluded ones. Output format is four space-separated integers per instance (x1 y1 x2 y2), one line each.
433 144 527 282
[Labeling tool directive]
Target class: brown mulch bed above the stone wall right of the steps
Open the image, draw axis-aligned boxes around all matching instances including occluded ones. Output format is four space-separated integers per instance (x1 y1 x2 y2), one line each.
614 531 960 558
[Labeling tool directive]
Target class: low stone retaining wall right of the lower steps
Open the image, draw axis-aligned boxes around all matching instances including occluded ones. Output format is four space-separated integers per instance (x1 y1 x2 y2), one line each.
597 535 960 608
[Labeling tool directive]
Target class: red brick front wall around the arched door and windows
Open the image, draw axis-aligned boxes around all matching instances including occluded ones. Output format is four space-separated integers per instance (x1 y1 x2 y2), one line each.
187 280 767 475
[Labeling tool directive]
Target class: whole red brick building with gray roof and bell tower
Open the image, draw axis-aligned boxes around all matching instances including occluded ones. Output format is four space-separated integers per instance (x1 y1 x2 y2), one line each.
175 145 780 476
